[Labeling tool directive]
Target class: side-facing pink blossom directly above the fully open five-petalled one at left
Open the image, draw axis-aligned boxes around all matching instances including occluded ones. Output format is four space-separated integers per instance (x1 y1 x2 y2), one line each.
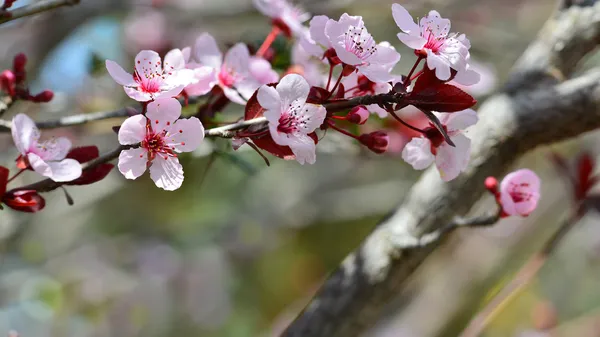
106 49 194 102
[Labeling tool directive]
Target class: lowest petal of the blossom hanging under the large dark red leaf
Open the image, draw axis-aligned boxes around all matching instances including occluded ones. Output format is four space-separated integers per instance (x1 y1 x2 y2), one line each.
435 134 471 181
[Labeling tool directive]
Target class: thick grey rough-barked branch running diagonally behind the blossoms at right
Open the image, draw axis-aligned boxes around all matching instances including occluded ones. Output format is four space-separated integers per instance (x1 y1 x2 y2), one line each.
282 3 600 337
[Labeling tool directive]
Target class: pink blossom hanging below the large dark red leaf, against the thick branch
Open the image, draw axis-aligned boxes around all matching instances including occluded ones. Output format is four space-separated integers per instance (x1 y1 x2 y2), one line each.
402 109 478 181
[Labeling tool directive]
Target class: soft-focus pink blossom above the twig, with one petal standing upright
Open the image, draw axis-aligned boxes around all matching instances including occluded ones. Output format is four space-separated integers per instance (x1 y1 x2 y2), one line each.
193 33 260 105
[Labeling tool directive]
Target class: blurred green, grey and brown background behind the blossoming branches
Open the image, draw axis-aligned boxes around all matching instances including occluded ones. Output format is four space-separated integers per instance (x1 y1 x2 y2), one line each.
0 0 600 337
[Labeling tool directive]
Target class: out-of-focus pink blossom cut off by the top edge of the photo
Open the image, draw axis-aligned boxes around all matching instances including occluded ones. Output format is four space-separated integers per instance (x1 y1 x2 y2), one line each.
254 0 310 36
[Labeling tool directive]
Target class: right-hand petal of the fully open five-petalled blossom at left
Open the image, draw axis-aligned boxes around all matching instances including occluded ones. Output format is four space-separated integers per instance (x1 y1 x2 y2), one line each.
165 117 204 152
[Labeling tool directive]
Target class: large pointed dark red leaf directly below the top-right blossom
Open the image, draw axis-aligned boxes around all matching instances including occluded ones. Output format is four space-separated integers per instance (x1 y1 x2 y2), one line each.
405 82 477 112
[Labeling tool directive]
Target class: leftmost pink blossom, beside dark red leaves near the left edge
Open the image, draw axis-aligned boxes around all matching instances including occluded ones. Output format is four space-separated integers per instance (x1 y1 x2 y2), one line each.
11 114 82 182
